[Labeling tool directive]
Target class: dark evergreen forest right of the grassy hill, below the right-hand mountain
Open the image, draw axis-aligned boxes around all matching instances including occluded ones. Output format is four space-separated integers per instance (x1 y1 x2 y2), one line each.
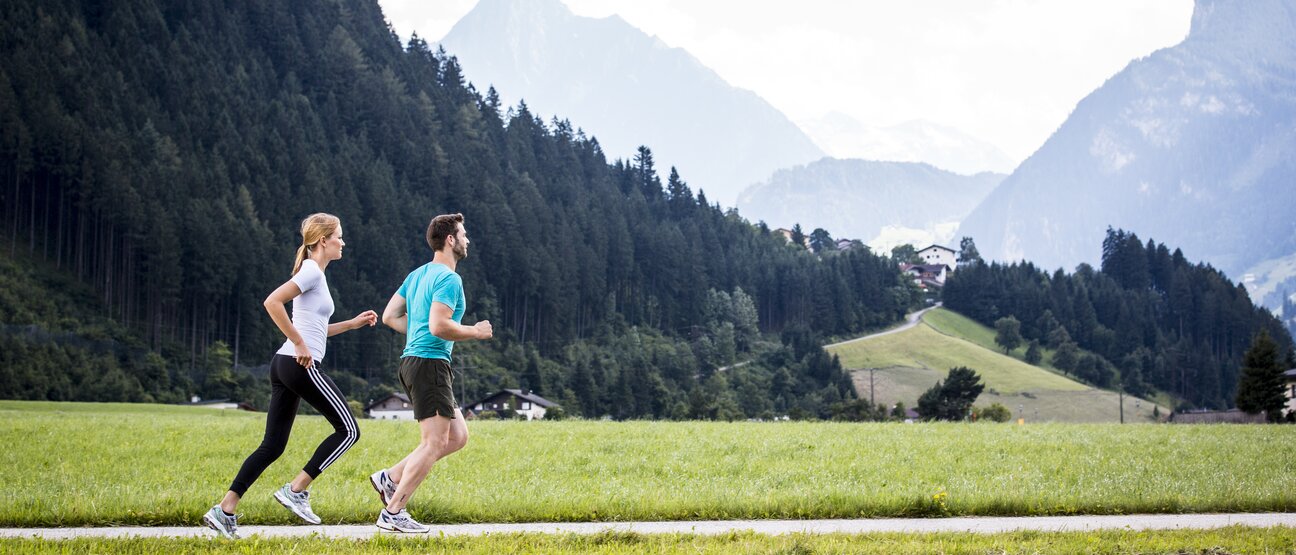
942 228 1292 408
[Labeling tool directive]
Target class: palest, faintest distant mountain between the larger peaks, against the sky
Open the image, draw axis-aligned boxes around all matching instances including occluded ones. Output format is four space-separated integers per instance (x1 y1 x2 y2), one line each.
797 112 1017 175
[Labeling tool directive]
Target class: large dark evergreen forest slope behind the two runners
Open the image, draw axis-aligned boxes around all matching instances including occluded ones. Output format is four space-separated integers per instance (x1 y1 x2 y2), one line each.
0 0 915 418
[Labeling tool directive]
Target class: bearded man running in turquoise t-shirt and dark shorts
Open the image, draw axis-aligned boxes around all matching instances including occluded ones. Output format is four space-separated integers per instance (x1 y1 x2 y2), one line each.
369 214 494 533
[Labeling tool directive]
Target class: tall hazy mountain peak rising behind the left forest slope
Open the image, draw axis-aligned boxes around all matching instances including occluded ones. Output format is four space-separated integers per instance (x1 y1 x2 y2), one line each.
441 0 823 206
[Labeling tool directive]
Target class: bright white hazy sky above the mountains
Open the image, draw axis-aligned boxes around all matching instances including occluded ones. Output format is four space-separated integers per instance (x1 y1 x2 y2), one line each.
380 0 1192 162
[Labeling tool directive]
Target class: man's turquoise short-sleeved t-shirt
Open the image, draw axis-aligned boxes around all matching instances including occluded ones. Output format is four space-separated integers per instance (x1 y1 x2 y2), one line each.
397 262 465 362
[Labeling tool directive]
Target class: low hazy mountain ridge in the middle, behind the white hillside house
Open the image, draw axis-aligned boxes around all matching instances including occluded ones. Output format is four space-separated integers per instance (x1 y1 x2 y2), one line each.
737 158 1004 249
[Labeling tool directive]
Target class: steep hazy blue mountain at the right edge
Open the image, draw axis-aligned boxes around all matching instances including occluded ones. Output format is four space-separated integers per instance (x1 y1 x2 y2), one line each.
959 0 1296 279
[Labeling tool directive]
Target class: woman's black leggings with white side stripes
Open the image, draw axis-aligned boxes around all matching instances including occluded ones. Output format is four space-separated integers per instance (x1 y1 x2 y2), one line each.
229 354 360 497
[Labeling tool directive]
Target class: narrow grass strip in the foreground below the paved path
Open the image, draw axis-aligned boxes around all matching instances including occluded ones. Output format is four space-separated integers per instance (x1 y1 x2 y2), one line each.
0 526 1296 555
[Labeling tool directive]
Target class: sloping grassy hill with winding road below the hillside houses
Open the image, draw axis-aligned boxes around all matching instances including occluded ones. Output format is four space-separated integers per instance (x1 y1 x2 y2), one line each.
828 309 1166 423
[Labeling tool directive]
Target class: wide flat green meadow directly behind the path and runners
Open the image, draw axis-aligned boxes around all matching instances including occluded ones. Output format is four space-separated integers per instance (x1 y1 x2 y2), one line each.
0 401 1296 526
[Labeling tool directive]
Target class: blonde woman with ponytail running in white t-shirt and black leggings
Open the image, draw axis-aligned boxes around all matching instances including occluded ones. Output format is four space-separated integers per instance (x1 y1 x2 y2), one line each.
202 214 378 538
